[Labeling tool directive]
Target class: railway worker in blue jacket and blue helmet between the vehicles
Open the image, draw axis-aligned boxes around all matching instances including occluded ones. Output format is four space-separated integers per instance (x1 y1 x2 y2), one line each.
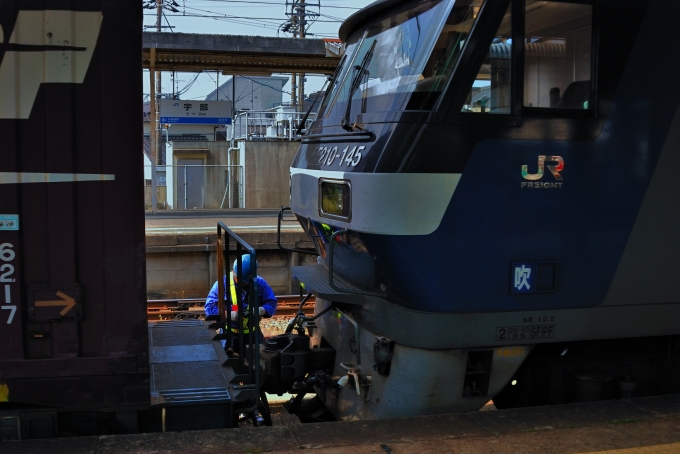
205 254 277 351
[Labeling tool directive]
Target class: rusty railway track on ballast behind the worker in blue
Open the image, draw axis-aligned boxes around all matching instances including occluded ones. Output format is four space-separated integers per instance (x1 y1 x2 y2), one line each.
146 295 316 321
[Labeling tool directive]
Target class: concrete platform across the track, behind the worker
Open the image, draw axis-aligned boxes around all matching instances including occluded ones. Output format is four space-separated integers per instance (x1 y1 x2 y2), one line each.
145 210 316 299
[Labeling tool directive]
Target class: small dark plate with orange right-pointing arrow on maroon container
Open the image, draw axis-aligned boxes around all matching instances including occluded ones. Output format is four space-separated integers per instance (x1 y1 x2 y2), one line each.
27 284 82 321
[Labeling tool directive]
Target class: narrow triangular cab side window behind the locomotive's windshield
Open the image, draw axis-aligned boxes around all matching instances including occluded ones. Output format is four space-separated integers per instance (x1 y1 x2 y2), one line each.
462 4 512 114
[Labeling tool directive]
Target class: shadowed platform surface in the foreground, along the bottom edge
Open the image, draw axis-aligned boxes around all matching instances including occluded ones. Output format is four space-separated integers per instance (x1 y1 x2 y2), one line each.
0 395 680 454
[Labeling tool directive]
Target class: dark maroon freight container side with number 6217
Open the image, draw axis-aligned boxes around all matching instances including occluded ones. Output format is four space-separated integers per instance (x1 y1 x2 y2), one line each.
0 0 149 410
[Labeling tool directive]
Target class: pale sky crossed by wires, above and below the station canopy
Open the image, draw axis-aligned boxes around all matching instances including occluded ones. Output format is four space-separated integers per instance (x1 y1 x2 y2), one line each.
143 0 374 101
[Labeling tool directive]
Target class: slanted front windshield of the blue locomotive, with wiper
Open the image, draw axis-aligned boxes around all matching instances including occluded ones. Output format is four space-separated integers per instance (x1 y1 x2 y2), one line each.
322 0 482 117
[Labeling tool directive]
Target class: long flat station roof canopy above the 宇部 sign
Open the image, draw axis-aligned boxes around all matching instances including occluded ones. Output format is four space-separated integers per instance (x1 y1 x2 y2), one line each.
142 32 340 75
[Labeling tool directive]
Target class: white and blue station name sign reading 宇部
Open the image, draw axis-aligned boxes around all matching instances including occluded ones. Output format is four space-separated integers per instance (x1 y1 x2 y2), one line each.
160 99 231 125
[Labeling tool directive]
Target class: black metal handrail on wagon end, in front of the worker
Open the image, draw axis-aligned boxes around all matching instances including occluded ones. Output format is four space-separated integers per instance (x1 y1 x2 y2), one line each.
217 221 260 413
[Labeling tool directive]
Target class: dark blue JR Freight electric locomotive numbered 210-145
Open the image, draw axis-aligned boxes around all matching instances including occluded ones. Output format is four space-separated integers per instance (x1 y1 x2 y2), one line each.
278 0 680 419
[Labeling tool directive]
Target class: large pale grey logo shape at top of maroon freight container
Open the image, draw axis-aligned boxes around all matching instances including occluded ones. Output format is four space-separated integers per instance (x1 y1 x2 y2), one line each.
0 10 102 120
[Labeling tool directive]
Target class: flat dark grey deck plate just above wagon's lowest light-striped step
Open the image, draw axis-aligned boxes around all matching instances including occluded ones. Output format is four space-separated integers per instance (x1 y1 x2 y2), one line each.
151 361 228 391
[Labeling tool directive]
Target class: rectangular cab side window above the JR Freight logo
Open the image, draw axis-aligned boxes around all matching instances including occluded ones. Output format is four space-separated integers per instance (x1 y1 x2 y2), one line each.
524 0 593 110
